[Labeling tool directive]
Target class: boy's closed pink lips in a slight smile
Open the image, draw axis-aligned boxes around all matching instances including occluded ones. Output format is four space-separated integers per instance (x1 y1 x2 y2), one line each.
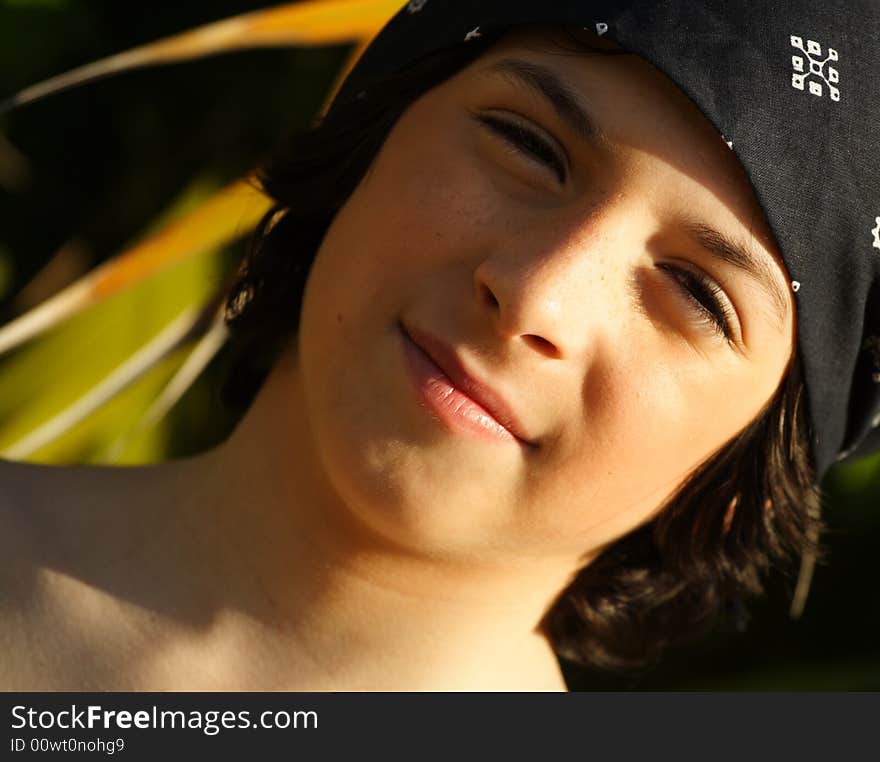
398 323 536 448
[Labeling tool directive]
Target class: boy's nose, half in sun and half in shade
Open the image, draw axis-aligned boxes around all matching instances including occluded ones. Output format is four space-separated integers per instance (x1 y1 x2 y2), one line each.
473 223 622 359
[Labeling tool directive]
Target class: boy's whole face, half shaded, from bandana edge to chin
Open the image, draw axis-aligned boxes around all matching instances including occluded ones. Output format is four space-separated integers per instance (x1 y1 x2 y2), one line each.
290 32 794 563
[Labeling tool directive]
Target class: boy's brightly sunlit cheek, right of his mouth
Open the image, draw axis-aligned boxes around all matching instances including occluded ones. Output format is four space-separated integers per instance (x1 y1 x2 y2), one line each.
525 356 772 552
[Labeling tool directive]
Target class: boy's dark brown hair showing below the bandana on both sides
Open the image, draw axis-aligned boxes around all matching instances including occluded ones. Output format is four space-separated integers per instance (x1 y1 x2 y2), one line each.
227 29 821 669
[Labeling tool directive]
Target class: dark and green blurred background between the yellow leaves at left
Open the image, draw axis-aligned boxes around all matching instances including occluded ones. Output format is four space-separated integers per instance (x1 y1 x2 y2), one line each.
0 0 347 463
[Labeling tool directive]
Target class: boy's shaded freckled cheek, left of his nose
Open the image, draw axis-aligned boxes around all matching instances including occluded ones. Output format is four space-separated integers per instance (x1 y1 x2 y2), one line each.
303 115 503 354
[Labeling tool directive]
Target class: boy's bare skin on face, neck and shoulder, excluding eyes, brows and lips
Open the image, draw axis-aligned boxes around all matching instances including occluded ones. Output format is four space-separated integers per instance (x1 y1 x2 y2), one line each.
0 30 794 690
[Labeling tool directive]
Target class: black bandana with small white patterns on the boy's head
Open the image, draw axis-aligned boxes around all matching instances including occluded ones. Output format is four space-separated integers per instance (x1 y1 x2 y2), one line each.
337 0 880 478
